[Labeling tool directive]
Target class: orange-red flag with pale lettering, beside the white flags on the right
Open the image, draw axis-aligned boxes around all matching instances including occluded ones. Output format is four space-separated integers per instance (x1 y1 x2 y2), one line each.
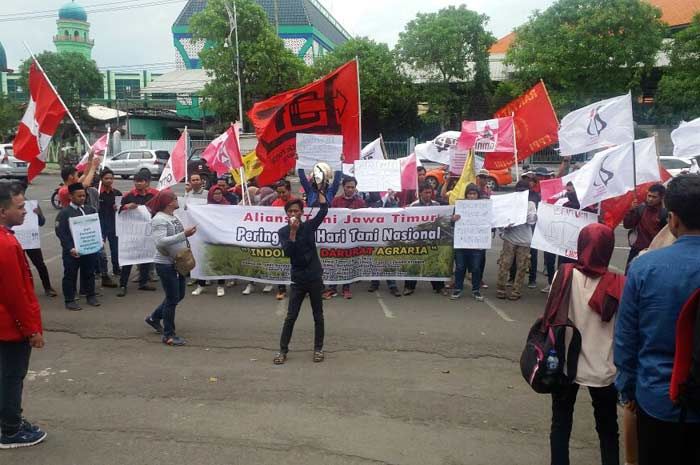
484 81 559 170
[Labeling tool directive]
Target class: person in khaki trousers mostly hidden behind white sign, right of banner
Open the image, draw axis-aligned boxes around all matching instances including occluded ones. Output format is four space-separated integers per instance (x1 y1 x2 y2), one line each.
496 179 537 300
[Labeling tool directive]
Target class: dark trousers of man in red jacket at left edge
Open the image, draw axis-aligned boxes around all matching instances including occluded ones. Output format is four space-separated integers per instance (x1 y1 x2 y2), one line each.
0 341 32 436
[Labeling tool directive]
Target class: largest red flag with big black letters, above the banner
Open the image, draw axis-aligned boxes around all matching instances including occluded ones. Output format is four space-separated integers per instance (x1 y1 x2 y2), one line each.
248 60 360 186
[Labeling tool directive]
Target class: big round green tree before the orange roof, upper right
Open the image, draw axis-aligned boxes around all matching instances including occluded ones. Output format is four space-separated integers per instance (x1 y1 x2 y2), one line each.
506 0 666 109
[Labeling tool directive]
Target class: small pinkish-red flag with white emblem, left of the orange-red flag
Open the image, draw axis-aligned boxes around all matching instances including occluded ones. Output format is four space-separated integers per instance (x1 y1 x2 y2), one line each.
457 116 515 153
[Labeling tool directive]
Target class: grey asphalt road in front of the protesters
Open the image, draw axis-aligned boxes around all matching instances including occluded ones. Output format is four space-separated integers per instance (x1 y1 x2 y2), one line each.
0 176 627 465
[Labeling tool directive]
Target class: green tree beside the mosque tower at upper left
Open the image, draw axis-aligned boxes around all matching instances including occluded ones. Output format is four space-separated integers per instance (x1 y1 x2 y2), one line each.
20 51 102 118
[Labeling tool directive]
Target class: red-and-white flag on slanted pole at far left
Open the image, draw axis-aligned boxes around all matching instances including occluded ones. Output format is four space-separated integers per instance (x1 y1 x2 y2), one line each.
12 63 66 181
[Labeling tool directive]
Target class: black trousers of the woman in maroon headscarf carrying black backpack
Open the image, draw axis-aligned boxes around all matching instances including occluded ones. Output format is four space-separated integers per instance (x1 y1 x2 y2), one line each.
549 384 620 465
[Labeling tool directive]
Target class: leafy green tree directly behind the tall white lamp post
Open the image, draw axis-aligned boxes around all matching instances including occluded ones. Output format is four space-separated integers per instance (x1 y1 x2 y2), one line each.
190 0 309 127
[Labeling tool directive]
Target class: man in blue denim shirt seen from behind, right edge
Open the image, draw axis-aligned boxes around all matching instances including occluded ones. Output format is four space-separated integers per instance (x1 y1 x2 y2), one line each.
615 175 700 465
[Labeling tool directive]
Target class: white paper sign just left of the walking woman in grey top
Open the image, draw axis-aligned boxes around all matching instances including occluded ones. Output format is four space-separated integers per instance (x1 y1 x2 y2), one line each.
116 205 156 265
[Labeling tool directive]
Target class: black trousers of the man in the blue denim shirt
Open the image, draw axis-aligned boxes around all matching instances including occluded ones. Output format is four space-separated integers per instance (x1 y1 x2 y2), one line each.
637 406 700 465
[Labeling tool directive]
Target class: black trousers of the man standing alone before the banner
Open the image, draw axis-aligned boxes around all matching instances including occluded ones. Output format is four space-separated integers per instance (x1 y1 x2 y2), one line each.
280 279 325 354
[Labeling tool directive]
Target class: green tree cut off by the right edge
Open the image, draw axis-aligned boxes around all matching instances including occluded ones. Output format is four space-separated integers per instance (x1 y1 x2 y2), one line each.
656 14 700 123
